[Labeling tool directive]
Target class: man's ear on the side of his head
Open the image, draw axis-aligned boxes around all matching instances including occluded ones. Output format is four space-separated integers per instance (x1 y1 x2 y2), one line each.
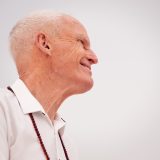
36 33 51 55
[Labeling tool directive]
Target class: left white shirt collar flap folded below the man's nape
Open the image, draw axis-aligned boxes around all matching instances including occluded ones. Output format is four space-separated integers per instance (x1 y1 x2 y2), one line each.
11 79 45 114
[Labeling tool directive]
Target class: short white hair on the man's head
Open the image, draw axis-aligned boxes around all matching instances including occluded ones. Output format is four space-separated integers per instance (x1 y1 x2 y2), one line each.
9 10 71 61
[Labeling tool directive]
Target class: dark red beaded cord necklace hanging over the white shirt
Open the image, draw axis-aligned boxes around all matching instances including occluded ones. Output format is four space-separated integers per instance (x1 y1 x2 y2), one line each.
7 86 69 160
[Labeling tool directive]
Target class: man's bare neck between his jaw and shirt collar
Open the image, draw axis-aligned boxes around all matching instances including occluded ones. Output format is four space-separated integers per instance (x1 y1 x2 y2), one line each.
20 72 70 120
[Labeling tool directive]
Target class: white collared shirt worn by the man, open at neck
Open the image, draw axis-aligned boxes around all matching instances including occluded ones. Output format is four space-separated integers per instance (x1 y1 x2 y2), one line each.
0 79 76 160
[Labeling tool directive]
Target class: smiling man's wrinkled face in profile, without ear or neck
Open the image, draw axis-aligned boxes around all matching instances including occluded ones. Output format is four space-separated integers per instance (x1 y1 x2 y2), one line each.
49 18 97 93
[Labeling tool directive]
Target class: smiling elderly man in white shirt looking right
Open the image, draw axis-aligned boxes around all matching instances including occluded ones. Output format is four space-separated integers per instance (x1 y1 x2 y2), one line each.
0 11 97 160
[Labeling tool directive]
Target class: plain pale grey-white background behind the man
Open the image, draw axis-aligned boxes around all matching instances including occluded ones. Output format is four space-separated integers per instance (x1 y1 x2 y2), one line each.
0 0 160 160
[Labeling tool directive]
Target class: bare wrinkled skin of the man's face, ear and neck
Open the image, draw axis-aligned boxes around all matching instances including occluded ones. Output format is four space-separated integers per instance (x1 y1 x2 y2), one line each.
20 17 98 119
